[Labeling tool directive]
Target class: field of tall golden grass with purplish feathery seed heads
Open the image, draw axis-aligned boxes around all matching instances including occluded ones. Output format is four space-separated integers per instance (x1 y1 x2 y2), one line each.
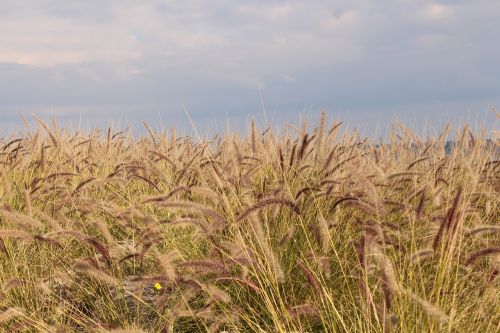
0 115 500 332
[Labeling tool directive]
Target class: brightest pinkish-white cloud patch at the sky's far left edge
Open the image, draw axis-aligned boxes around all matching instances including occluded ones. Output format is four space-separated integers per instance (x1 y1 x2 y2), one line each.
0 17 141 66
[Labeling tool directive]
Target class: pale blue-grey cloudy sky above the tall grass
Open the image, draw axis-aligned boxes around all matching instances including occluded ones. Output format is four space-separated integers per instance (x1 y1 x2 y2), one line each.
0 0 500 135
